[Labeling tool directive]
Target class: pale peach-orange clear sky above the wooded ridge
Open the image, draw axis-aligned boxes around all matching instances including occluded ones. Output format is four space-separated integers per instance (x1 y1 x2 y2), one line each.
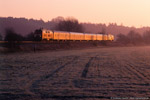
0 0 150 27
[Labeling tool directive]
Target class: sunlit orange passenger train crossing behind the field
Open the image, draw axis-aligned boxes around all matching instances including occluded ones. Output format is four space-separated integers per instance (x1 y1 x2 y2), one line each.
36 29 114 41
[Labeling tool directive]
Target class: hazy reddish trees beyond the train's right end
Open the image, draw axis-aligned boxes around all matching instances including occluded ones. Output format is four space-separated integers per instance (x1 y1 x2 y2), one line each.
117 31 150 45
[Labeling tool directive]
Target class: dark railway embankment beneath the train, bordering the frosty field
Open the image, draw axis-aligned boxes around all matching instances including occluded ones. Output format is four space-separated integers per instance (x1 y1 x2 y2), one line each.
0 41 113 52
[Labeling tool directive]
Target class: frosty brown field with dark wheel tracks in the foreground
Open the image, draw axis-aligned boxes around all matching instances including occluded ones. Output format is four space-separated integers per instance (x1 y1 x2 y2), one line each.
0 47 150 100
